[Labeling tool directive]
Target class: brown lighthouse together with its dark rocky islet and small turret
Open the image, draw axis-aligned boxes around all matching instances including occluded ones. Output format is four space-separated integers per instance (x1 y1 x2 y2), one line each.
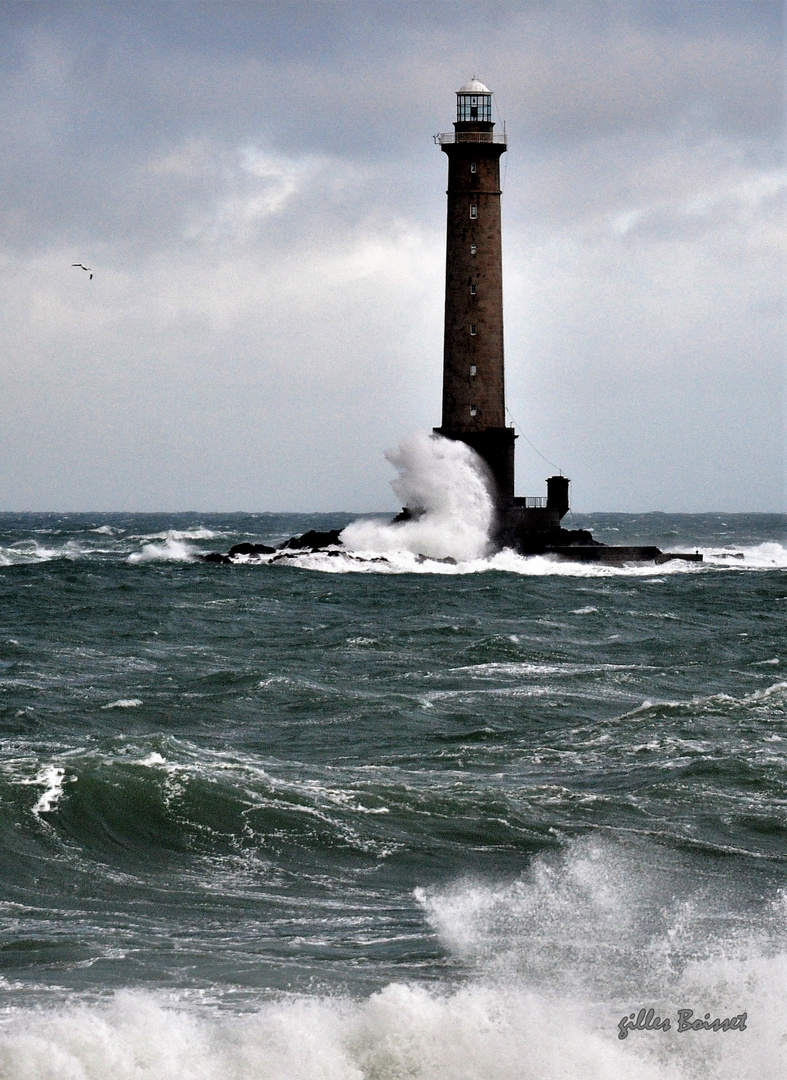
201 78 703 566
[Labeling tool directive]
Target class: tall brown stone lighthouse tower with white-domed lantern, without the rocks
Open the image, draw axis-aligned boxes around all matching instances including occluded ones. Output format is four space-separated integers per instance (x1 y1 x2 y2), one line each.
435 79 515 510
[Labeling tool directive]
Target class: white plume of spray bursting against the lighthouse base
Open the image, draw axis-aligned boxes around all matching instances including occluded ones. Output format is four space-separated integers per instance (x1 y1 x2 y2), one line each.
341 432 493 562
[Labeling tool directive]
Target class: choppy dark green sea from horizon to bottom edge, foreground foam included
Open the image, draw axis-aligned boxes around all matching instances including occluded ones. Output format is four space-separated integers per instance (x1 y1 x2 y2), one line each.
0 514 787 1080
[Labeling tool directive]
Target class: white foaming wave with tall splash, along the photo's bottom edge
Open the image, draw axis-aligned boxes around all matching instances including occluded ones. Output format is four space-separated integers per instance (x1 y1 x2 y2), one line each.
0 839 787 1080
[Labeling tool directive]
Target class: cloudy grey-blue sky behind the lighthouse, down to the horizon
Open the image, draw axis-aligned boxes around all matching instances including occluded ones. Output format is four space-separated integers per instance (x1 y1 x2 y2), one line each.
0 0 786 511
